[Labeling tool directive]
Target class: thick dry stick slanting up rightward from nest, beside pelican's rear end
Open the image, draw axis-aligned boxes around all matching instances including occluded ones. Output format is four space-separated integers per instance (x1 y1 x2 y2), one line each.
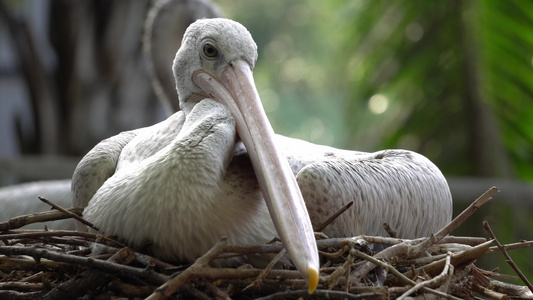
408 186 500 257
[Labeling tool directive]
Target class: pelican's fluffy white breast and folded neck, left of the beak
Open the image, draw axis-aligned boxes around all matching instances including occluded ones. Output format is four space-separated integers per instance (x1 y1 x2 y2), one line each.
84 99 275 260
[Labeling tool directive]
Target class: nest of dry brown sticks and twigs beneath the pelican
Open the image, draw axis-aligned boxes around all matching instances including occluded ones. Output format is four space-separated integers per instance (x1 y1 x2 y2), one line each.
0 188 533 299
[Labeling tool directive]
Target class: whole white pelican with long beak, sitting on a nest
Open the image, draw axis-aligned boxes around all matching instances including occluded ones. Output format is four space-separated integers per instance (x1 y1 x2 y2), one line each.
72 18 452 292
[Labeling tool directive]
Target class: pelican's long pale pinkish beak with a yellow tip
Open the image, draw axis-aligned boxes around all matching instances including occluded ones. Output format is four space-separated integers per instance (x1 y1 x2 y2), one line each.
193 60 319 293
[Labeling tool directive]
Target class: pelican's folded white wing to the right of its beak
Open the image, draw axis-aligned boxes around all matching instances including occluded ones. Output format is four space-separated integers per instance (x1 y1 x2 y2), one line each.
296 150 452 238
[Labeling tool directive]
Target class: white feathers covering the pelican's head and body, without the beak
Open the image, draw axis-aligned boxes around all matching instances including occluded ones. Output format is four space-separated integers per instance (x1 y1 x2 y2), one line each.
73 19 452 268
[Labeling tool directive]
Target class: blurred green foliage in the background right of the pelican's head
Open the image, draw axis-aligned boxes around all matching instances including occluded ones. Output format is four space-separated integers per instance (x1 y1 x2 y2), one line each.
217 0 533 284
